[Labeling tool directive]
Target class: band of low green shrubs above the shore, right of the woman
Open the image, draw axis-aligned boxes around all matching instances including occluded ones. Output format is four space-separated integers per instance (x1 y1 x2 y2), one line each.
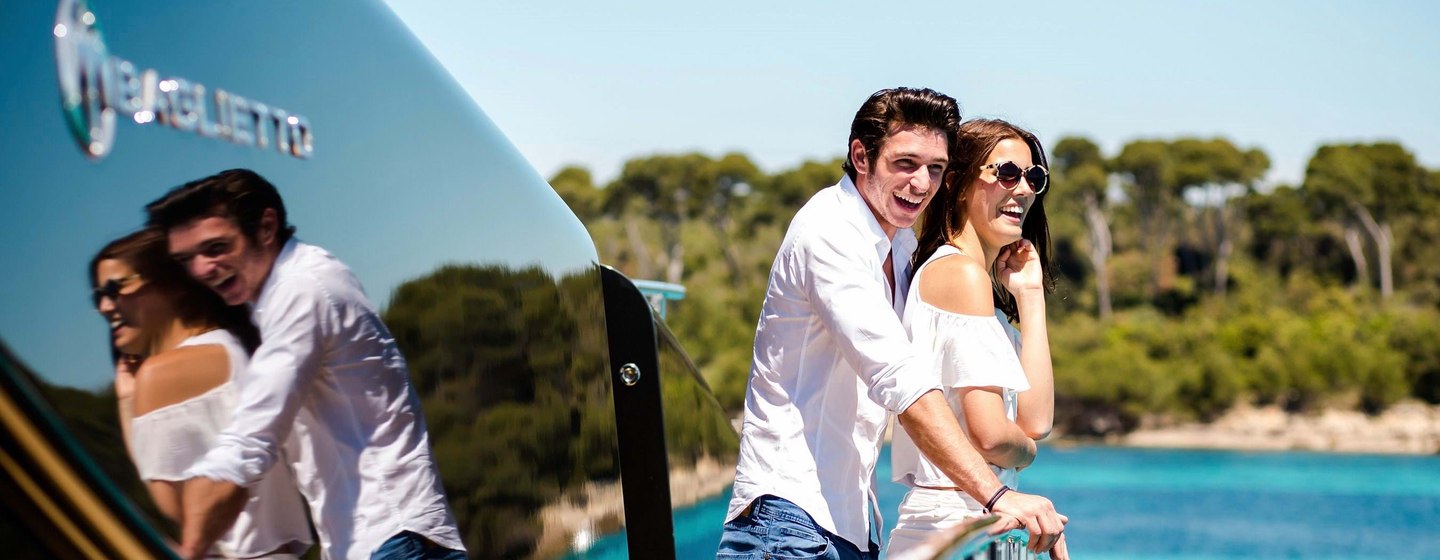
1051 270 1440 433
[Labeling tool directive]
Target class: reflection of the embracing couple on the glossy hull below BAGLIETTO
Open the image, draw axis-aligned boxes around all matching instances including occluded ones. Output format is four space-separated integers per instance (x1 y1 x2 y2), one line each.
91 170 464 559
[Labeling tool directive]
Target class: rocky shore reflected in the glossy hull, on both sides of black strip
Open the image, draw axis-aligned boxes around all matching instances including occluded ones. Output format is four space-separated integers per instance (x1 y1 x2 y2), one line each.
536 458 734 559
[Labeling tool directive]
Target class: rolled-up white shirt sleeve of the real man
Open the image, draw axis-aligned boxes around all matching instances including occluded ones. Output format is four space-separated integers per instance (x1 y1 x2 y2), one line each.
793 226 939 413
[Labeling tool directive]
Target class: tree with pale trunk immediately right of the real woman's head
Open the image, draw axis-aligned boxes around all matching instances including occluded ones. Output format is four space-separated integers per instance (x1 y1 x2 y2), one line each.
1051 137 1115 321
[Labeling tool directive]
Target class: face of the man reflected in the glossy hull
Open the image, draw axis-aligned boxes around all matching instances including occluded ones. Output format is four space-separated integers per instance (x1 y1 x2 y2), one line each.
168 216 278 305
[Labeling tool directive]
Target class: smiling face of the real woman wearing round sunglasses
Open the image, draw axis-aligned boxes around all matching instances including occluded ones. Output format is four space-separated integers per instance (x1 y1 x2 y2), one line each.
965 138 1035 249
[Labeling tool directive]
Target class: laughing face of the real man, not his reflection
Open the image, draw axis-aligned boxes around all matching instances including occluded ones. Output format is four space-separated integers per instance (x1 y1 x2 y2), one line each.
850 124 950 238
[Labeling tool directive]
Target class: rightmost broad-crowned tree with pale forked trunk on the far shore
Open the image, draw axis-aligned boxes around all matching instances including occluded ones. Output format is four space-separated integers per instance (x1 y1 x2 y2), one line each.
1302 143 1427 299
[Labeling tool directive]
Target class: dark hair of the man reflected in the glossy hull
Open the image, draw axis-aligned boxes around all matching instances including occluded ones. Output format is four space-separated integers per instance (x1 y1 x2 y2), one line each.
145 168 295 245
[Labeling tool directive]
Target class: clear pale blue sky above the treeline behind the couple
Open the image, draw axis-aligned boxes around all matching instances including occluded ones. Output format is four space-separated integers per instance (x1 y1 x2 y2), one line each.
387 0 1440 183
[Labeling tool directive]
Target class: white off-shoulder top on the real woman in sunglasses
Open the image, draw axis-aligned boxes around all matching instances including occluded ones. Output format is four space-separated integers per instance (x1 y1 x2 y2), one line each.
890 245 1030 500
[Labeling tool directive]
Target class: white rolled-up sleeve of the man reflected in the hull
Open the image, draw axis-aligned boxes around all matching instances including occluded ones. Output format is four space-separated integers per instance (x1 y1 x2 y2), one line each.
186 281 333 487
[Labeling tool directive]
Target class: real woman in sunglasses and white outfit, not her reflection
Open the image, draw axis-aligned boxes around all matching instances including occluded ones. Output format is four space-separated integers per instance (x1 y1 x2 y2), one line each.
888 119 1066 559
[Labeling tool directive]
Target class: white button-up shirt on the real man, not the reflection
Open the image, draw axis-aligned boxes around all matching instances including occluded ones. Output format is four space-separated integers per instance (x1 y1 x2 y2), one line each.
726 177 937 550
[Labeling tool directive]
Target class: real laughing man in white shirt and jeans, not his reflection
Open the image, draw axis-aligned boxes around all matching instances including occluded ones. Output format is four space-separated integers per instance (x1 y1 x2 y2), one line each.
720 88 1066 559
